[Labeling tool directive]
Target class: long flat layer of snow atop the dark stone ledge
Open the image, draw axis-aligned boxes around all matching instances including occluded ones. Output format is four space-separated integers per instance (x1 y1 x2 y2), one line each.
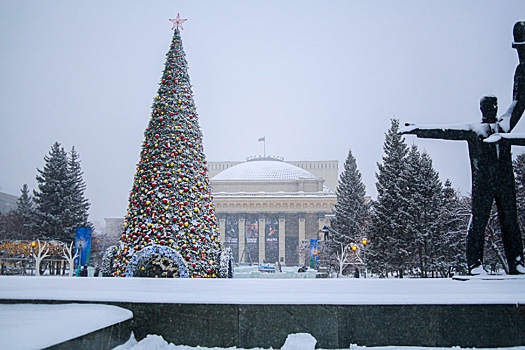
0 276 525 305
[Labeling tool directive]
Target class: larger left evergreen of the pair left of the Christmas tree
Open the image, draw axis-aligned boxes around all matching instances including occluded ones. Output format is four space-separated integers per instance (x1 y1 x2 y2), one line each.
33 142 71 242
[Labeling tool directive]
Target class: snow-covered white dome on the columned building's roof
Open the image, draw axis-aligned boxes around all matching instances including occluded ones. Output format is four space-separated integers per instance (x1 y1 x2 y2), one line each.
212 158 316 181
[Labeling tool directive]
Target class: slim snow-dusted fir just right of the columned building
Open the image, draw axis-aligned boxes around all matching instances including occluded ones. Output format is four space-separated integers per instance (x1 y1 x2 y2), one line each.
327 150 370 270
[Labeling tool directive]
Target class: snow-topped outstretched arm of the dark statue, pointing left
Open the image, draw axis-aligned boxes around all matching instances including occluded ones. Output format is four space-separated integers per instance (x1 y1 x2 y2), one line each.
399 123 473 140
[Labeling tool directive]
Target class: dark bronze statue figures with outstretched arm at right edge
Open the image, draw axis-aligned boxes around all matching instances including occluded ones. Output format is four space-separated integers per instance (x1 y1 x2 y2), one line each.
400 22 525 275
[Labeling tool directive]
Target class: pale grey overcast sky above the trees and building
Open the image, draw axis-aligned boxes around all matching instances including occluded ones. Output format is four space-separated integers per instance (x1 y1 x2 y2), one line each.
0 0 525 226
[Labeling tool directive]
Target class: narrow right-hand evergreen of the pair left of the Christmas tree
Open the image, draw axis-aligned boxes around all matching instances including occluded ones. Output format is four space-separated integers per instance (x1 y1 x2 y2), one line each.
68 146 93 228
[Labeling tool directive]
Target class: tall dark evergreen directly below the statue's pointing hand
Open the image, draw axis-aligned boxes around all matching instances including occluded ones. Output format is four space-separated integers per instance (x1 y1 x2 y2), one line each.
368 119 409 277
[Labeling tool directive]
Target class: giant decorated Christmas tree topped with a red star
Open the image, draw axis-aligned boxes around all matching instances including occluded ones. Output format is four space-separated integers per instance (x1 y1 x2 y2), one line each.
113 15 231 277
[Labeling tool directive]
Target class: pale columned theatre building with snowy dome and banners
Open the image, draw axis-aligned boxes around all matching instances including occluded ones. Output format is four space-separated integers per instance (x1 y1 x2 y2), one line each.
208 157 338 265
